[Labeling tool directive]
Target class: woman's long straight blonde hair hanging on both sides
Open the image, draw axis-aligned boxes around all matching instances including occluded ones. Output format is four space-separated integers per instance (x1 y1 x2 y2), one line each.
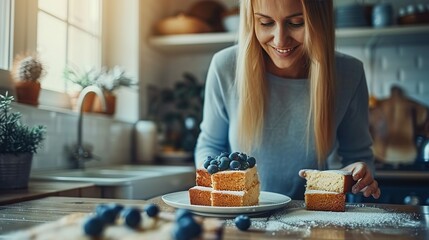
236 0 335 165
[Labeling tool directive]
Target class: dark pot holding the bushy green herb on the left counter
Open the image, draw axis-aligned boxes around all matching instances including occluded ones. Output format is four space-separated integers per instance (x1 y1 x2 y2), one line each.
0 153 33 189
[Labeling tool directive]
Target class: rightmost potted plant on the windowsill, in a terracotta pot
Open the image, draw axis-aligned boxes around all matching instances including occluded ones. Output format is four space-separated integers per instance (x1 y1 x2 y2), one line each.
93 66 137 115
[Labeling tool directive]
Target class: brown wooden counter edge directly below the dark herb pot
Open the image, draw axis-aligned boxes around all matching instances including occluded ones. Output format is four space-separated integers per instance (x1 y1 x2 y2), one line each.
0 181 100 205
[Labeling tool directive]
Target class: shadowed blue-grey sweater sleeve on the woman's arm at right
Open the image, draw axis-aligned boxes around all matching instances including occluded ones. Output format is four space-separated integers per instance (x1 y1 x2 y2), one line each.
337 64 374 170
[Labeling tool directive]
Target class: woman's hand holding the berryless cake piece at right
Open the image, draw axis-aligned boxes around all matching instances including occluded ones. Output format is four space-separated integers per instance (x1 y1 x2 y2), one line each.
341 162 381 199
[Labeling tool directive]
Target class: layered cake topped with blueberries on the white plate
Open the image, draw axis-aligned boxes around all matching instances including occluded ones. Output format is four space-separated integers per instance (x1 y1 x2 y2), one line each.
189 152 260 207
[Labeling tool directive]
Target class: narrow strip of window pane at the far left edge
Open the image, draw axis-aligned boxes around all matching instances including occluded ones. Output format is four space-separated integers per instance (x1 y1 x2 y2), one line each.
0 0 12 70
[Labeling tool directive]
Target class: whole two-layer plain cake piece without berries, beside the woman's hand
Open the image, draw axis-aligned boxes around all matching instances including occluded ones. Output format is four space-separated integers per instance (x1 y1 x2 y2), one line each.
304 169 355 212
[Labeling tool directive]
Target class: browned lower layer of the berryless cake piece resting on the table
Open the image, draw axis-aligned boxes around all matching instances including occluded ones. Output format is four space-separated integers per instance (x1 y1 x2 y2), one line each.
305 190 346 212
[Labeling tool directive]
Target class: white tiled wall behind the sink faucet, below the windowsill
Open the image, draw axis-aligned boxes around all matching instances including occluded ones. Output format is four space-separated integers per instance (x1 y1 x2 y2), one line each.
12 104 133 172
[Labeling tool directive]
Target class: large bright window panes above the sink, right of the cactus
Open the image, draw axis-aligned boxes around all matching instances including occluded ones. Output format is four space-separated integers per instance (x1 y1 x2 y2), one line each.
37 0 102 92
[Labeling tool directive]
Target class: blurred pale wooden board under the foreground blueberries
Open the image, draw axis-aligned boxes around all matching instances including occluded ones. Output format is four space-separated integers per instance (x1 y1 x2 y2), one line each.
10 212 224 240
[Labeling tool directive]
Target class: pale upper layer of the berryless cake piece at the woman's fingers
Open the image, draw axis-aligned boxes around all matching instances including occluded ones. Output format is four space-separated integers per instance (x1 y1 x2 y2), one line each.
304 170 354 193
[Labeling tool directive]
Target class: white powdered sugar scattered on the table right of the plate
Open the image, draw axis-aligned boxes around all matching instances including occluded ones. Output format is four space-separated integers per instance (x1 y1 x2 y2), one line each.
226 205 420 231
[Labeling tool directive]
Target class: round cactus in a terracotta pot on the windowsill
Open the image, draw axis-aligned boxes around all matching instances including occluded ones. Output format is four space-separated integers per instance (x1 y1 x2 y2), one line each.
11 55 43 106
